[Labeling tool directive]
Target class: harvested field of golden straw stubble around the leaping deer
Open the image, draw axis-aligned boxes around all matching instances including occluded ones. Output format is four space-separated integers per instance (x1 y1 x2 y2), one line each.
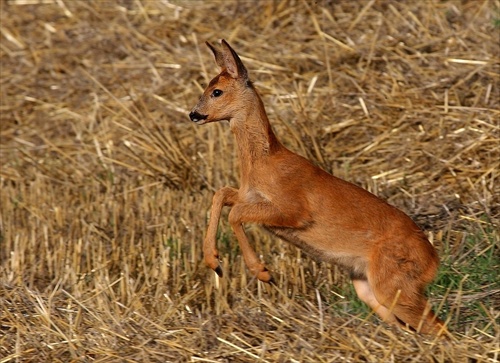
0 0 500 363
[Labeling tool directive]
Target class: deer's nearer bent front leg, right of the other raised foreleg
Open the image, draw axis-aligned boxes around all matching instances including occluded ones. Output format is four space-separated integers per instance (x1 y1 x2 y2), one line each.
229 202 308 283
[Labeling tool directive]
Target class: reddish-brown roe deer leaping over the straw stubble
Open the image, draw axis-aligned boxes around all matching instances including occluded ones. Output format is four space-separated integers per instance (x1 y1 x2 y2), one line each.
189 40 448 335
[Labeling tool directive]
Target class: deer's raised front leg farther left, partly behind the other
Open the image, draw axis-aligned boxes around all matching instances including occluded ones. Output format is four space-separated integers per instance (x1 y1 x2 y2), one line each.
203 187 238 277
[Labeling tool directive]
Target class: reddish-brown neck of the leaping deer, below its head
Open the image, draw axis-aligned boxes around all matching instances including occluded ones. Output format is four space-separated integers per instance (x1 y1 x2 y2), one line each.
230 93 282 181
